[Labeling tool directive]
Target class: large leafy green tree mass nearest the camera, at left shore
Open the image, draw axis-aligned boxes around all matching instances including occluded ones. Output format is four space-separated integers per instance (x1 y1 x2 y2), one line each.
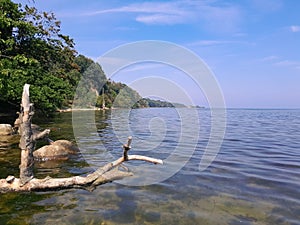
0 0 80 112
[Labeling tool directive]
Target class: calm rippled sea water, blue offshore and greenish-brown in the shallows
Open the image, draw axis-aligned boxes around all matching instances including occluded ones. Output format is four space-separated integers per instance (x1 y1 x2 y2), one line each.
0 108 300 225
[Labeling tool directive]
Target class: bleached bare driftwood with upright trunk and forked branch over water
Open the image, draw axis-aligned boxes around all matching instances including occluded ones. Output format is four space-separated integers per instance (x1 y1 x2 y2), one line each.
0 84 163 193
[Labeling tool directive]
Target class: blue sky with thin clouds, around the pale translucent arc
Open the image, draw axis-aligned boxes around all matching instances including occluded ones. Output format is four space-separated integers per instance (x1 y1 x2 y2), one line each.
14 0 300 108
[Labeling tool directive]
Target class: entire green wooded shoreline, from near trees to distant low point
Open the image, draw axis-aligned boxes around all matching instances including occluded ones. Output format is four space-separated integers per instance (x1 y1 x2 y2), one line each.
0 0 184 114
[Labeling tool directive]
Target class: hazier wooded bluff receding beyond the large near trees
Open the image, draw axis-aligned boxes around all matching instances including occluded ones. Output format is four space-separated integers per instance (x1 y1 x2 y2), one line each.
73 55 185 108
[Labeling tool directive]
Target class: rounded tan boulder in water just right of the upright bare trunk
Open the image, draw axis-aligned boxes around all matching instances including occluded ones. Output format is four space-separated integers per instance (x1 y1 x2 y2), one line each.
33 140 79 161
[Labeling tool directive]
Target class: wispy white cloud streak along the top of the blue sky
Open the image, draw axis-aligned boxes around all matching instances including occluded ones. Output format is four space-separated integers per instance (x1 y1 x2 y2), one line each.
84 0 241 32
